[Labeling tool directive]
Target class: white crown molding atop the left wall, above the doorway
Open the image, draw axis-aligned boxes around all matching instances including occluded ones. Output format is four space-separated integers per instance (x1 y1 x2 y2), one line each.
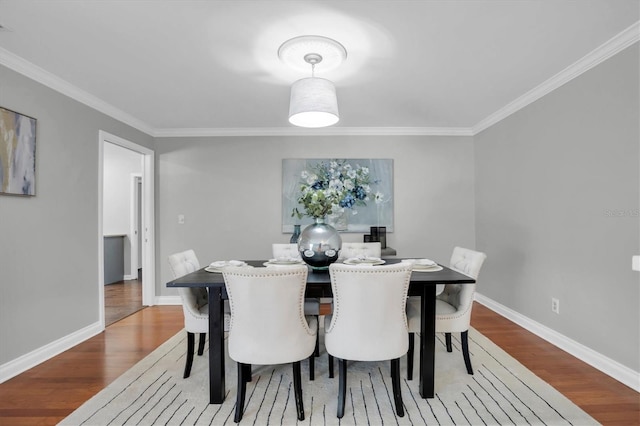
0 47 153 136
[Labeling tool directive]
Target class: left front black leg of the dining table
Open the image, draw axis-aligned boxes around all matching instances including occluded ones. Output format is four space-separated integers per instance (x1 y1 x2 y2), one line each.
209 287 225 404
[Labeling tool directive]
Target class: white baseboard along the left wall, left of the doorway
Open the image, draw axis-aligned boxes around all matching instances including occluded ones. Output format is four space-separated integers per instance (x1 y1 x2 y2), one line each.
0 322 104 383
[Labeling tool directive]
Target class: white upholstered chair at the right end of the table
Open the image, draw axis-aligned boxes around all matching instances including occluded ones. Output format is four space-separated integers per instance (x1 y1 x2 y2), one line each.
407 247 487 380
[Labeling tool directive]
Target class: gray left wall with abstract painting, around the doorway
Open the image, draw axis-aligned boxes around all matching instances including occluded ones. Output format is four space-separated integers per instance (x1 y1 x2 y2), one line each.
0 66 153 365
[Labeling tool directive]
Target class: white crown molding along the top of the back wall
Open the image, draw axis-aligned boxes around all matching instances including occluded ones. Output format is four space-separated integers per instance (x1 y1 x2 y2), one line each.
153 127 473 138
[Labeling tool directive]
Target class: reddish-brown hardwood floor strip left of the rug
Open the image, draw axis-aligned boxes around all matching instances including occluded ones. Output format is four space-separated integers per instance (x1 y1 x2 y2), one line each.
0 306 184 426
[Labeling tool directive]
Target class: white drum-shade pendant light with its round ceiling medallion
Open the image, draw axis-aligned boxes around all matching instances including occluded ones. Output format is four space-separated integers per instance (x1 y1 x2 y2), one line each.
278 36 347 127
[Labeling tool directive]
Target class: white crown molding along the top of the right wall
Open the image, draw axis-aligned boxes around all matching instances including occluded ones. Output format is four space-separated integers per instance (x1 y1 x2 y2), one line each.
472 21 640 135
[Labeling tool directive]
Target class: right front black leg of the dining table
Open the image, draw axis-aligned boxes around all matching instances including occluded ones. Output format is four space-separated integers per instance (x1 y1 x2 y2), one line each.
419 285 436 399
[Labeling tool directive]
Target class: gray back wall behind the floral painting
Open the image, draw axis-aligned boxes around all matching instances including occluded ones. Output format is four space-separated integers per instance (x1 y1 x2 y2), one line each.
156 136 475 295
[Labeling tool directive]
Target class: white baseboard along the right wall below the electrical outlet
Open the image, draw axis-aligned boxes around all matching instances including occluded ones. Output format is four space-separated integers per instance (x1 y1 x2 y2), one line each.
475 293 640 392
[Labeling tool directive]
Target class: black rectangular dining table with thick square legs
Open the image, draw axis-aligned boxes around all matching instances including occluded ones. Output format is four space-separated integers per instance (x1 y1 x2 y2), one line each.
167 258 475 404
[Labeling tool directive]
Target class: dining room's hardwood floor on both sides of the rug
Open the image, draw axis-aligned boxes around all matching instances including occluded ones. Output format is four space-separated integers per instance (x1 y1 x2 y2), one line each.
0 303 640 426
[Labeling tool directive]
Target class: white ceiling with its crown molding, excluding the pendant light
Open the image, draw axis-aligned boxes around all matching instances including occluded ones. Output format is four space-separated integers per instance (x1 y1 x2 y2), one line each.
0 0 640 136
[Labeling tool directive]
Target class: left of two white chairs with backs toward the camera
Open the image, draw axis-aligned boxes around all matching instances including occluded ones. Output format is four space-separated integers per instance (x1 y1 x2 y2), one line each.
223 265 317 423
